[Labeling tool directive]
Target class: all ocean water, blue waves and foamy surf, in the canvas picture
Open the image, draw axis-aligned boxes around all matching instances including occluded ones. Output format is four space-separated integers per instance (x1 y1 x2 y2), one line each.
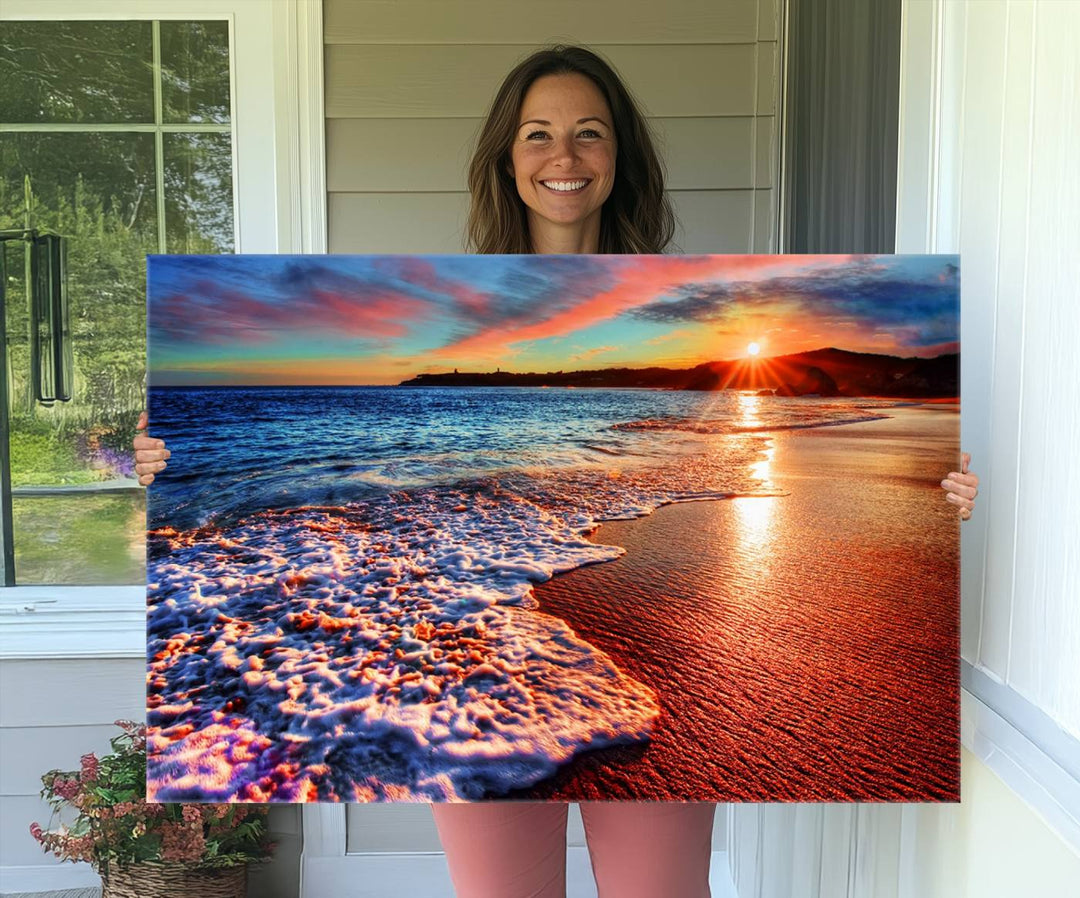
147 387 896 801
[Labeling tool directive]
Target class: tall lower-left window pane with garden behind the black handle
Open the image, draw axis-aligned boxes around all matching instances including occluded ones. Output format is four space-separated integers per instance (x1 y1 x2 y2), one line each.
0 133 158 584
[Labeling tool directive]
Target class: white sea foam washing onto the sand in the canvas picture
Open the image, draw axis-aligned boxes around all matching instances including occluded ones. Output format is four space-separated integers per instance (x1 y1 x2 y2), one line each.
148 435 762 801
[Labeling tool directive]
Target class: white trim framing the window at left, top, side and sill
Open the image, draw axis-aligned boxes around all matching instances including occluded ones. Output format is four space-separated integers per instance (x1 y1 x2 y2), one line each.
0 0 326 659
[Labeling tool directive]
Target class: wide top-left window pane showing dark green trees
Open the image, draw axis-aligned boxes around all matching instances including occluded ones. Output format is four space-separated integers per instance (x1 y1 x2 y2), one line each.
0 22 153 123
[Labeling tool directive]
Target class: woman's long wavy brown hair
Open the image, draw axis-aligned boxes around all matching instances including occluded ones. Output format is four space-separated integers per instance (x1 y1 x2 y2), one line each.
468 45 675 253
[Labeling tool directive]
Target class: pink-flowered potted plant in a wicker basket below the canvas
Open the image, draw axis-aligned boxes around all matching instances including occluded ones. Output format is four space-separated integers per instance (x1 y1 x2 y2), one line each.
30 721 274 898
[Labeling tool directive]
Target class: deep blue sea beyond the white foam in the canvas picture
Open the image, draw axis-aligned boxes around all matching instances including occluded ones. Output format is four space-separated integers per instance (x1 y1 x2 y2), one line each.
150 387 894 528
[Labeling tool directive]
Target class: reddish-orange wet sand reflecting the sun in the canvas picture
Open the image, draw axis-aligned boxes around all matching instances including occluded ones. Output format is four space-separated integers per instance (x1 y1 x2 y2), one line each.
508 405 959 801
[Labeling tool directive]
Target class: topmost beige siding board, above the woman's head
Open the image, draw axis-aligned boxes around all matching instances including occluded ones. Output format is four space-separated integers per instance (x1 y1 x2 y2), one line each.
323 0 772 46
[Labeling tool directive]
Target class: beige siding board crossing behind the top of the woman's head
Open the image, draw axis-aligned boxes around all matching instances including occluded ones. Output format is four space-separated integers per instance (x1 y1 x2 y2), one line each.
325 43 764 119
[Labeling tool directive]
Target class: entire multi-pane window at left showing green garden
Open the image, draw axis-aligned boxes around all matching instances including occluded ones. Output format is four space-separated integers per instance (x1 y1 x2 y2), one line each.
0 21 234 584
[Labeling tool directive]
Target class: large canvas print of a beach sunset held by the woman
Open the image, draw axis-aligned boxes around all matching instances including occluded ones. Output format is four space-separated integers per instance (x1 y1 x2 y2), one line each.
147 255 959 802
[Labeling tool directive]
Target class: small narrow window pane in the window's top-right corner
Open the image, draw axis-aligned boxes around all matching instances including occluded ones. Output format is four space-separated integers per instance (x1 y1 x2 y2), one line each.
161 22 229 123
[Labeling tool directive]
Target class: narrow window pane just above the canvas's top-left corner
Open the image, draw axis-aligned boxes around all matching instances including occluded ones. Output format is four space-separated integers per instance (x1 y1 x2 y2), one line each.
164 134 233 253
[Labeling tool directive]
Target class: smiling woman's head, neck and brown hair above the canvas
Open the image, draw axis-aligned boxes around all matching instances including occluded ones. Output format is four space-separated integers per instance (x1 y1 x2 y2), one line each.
468 46 675 253
